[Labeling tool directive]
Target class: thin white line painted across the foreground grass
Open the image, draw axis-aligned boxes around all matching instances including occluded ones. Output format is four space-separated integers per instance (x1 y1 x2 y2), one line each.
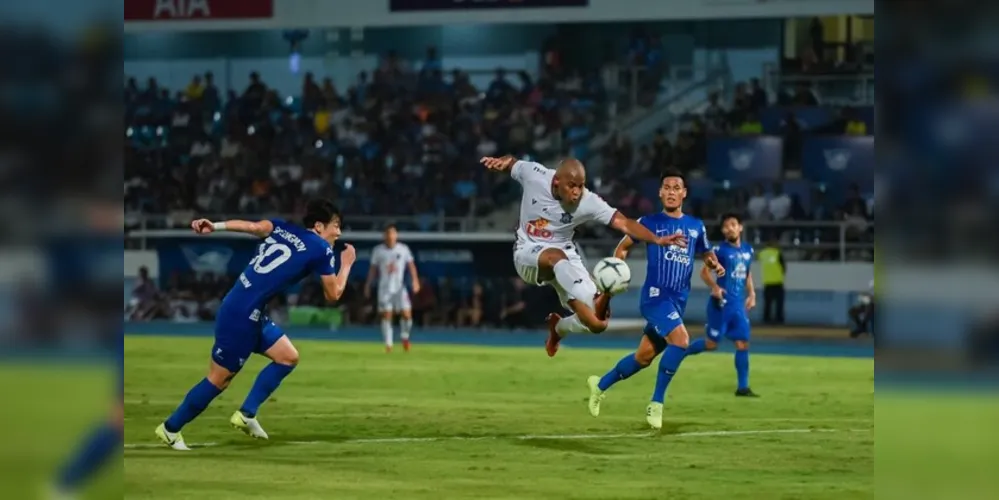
125 429 873 449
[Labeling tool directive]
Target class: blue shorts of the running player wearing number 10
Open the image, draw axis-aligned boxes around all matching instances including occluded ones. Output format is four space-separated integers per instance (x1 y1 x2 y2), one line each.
212 311 284 373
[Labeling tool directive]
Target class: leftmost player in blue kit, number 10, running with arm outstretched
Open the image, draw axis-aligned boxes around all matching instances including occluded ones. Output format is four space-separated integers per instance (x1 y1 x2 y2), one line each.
156 200 355 450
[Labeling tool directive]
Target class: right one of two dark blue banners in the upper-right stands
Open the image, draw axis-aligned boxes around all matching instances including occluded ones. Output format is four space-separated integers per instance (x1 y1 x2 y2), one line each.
801 136 874 190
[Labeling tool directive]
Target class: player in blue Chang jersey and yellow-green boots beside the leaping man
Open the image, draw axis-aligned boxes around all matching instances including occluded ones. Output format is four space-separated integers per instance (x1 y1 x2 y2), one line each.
587 170 725 429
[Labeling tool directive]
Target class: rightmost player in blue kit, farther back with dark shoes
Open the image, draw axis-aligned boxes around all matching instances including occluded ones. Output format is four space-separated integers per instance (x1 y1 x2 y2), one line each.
687 214 757 397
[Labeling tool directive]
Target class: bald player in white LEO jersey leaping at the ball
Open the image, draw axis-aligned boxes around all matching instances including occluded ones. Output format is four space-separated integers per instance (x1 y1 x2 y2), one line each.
479 156 686 356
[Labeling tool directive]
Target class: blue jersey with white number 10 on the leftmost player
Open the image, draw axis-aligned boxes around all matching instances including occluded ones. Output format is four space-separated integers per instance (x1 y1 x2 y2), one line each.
220 219 342 320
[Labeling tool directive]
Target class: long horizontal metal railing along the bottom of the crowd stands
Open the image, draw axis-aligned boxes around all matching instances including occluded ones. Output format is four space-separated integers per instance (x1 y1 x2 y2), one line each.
125 214 874 262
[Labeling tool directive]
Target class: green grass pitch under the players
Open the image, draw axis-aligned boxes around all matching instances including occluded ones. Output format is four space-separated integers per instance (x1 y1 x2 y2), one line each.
119 337 874 500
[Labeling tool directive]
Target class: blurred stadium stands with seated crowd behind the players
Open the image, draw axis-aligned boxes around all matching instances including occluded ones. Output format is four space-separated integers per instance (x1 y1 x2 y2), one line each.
122 0 875 341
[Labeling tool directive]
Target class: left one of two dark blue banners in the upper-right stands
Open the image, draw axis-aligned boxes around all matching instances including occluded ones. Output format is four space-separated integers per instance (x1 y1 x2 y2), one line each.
708 137 784 183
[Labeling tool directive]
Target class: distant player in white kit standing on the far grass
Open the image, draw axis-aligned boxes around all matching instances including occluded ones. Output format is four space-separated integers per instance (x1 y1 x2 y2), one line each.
364 226 420 352
